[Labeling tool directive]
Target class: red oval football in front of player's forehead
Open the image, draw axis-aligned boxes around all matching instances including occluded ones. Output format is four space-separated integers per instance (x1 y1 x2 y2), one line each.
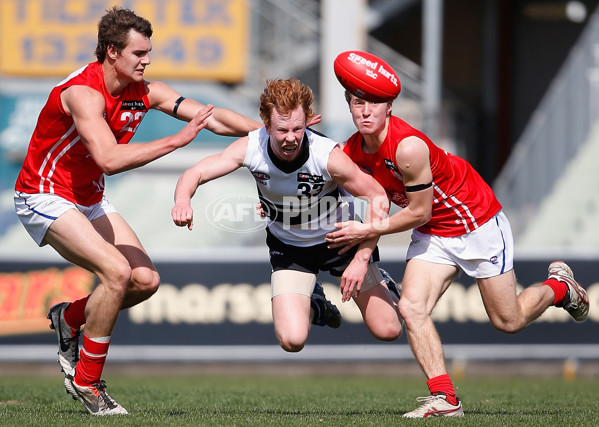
333 50 401 102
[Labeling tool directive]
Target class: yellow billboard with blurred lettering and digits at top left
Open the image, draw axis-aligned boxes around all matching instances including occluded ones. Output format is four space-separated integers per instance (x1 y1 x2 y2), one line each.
0 0 249 83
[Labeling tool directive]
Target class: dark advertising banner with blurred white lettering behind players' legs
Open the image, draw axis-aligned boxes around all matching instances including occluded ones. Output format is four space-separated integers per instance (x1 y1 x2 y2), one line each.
0 260 599 345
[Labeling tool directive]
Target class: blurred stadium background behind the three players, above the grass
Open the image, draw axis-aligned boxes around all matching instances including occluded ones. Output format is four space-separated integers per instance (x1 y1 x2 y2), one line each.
0 0 599 375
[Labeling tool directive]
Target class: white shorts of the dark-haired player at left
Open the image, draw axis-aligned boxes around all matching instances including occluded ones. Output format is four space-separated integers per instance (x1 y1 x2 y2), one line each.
14 191 116 246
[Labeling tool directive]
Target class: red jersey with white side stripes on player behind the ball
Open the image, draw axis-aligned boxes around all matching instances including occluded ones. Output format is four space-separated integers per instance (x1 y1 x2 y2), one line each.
344 116 501 237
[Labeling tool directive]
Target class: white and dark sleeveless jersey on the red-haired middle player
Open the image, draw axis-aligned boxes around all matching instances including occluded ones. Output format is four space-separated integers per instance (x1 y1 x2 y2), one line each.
243 128 354 247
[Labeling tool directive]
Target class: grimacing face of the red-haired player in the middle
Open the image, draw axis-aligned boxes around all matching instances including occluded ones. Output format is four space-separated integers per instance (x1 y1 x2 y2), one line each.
266 107 306 162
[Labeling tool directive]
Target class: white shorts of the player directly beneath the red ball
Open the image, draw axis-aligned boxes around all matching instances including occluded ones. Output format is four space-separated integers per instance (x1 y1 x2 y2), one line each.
406 211 514 279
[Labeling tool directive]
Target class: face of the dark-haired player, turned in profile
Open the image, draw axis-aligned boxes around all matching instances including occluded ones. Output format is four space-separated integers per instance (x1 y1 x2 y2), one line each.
114 30 152 82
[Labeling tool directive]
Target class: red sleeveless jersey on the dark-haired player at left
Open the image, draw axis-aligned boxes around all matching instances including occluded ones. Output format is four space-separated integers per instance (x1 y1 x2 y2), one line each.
15 62 150 206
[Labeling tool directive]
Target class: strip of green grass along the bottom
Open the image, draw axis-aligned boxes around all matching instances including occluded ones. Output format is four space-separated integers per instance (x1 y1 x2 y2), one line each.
0 375 599 427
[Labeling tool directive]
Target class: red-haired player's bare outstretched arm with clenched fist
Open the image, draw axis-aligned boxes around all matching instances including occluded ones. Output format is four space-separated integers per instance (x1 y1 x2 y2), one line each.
171 137 248 230
